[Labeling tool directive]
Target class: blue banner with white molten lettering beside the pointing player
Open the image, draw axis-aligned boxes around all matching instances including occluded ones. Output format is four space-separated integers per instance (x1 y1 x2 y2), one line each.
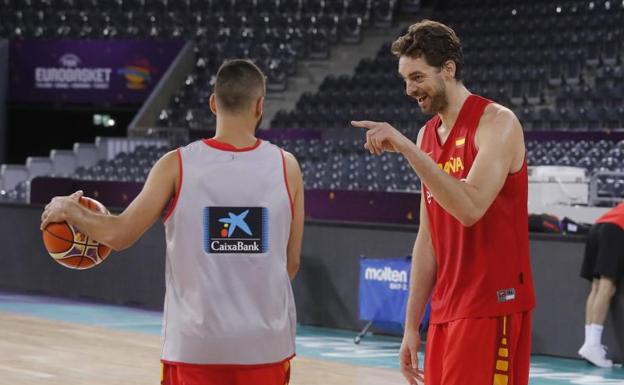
359 257 411 324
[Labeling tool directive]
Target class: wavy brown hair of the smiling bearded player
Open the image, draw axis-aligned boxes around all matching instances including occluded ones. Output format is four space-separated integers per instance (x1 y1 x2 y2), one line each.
391 20 464 81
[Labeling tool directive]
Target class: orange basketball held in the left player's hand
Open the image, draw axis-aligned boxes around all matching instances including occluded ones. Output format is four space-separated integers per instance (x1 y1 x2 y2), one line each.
43 197 111 270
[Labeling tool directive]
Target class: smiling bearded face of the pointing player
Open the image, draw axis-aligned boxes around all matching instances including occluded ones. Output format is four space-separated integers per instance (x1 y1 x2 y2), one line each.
399 56 448 115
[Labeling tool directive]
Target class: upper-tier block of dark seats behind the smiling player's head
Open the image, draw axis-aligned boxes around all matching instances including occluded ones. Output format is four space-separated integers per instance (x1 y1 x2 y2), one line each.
272 1 624 131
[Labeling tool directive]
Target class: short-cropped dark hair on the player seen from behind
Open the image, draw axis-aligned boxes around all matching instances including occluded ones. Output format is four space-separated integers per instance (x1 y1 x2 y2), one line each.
214 59 266 112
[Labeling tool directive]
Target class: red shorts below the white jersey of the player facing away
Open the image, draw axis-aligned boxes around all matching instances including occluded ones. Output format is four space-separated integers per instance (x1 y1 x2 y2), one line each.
160 359 290 385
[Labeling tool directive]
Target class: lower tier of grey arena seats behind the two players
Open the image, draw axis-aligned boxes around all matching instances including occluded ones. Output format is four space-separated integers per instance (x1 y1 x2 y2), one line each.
0 139 624 202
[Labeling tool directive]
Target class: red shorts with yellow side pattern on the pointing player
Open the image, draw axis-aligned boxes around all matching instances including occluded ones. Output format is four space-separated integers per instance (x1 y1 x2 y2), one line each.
425 311 531 385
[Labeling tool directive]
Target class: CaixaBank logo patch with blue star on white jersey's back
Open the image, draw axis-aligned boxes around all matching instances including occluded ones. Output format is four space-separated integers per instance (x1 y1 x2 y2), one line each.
204 207 269 254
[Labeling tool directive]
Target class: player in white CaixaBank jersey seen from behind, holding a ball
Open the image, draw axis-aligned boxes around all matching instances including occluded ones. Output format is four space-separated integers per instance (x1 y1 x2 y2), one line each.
41 60 304 385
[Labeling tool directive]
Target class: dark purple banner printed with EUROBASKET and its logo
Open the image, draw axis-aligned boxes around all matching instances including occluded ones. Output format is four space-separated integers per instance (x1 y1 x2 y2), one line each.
9 40 184 105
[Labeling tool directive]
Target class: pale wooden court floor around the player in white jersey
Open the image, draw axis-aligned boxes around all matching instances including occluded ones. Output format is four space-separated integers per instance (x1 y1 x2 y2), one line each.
0 313 406 385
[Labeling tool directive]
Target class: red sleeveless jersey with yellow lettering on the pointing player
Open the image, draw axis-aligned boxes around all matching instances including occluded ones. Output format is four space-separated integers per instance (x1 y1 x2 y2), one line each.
421 95 535 323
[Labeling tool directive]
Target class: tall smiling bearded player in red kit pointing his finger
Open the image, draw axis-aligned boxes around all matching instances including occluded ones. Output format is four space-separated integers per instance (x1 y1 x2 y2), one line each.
352 20 534 385
